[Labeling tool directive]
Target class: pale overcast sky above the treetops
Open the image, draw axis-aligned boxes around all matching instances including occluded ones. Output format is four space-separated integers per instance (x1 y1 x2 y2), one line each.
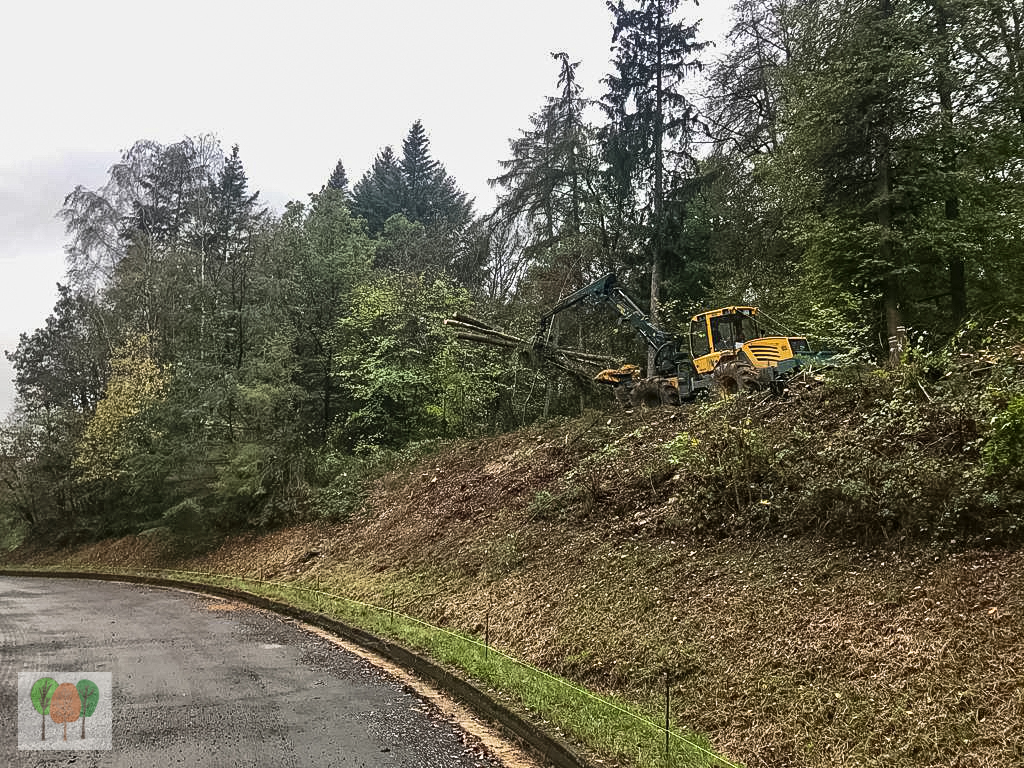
0 0 731 415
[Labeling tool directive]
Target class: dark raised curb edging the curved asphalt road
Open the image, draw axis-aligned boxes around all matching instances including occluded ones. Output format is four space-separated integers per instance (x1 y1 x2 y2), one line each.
0 568 592 768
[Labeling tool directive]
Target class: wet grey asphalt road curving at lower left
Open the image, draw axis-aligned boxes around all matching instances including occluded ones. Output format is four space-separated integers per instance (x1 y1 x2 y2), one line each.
0 578 500 768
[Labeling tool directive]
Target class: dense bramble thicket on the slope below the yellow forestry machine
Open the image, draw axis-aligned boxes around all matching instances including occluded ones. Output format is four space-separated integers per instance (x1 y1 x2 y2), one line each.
657 327 1024 544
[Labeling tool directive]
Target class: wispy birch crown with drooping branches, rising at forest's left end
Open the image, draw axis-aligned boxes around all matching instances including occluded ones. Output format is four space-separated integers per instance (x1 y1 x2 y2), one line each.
60 136 224 356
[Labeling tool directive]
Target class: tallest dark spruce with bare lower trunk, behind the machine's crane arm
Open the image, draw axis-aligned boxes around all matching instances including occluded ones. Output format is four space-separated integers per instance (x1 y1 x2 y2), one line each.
601 0 708 372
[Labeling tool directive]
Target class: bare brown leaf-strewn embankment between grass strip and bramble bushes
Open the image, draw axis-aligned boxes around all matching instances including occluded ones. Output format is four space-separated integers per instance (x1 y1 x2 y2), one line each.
8 412 1024 768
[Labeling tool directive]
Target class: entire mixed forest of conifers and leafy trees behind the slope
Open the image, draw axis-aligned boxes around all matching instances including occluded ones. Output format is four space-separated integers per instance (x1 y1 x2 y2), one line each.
0 0 1024 543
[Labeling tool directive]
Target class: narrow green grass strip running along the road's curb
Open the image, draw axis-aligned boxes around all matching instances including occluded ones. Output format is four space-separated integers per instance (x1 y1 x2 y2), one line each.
2 566 735 768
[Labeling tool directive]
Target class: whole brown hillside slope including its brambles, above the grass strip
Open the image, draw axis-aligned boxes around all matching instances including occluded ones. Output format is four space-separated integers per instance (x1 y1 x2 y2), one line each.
16 382 1024 768
